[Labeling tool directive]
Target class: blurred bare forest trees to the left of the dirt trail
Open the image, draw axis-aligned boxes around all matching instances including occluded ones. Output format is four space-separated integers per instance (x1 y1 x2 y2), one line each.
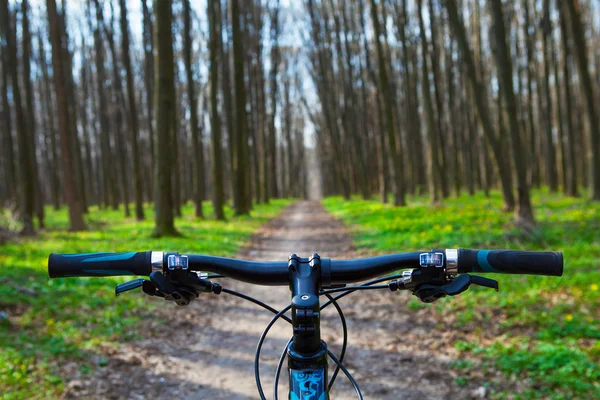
0 0 307 235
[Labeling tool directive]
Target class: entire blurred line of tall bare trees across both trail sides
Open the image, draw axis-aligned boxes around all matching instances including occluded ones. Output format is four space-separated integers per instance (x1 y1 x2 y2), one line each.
0 0 600 235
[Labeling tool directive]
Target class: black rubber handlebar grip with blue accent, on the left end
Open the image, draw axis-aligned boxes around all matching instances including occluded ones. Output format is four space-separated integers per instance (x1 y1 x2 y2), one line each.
48 251 152 278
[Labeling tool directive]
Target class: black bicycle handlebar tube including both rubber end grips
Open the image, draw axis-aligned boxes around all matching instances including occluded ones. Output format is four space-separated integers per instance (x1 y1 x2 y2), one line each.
48 249 563 286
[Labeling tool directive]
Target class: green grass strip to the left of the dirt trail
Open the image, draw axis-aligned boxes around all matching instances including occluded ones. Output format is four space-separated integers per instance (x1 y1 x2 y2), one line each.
0 200 290 399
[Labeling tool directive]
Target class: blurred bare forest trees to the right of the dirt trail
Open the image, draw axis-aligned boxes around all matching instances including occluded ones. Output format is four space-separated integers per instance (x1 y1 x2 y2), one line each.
304 0 600 226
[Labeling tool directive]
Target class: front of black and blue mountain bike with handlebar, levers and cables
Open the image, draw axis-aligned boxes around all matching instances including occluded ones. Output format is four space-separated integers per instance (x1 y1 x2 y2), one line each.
48 249 563 400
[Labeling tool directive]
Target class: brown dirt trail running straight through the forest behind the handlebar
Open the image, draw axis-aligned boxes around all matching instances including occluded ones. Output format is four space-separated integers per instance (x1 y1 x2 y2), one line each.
63 201 485 400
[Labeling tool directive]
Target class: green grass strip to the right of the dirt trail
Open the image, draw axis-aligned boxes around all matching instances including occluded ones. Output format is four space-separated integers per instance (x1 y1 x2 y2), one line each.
324 190 600 399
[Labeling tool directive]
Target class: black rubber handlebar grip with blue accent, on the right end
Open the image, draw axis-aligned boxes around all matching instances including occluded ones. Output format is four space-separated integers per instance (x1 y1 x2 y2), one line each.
458 249 563 276
